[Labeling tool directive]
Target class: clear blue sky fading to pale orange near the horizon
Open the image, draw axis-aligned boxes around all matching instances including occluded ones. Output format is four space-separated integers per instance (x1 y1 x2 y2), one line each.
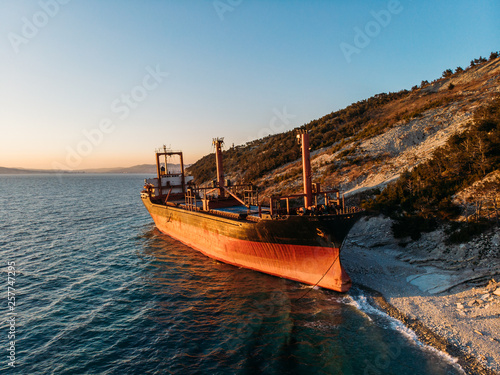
0 0 500 170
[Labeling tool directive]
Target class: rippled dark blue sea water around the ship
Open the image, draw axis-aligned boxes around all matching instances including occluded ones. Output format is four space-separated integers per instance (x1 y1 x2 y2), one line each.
0 175 461 374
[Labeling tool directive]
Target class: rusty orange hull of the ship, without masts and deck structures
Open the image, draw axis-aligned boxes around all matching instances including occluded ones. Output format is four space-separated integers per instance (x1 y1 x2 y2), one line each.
142 195 355 292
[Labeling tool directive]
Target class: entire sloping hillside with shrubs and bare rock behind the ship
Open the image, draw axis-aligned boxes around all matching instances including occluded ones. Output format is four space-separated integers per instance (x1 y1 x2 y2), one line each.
189 52 500 241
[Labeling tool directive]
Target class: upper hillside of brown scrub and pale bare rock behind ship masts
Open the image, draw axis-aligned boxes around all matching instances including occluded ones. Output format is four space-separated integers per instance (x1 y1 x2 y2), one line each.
189 53 500 225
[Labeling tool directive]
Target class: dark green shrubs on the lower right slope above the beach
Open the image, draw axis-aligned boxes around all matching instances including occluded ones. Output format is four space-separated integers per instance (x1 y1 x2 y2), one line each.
365 95 500 241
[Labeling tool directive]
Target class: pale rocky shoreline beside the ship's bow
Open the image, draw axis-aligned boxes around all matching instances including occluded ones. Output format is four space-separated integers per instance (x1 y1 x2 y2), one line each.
342 217 500 375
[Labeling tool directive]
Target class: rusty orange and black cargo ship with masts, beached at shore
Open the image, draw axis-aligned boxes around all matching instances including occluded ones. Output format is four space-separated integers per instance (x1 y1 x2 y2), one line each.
141 130 360 292
